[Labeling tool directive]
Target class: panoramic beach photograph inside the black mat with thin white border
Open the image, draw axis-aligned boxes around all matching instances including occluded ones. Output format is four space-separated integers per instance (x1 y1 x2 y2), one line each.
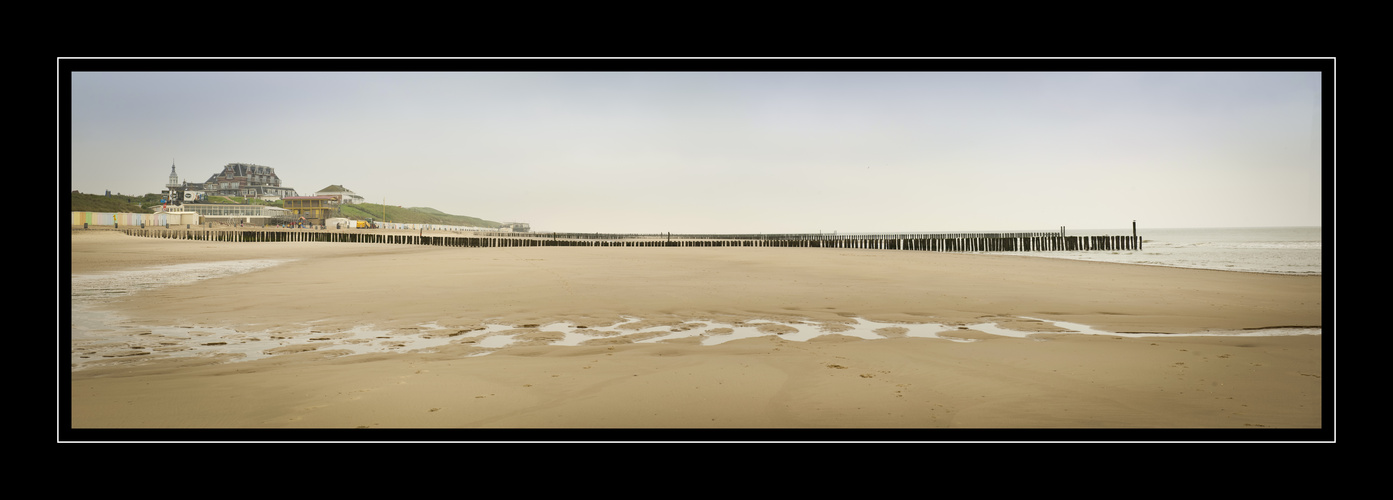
57 58 1334 443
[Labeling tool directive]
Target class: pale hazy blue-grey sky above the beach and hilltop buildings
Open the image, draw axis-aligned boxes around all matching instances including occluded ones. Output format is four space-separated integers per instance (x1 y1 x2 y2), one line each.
59 64 1322 233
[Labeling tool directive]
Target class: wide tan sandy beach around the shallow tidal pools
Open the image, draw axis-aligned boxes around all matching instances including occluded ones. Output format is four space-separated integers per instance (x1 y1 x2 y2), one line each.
60 230 1329 440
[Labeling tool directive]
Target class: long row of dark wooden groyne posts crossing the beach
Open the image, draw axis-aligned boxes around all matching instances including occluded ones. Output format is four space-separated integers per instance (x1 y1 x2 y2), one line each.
120 227 1142 252
